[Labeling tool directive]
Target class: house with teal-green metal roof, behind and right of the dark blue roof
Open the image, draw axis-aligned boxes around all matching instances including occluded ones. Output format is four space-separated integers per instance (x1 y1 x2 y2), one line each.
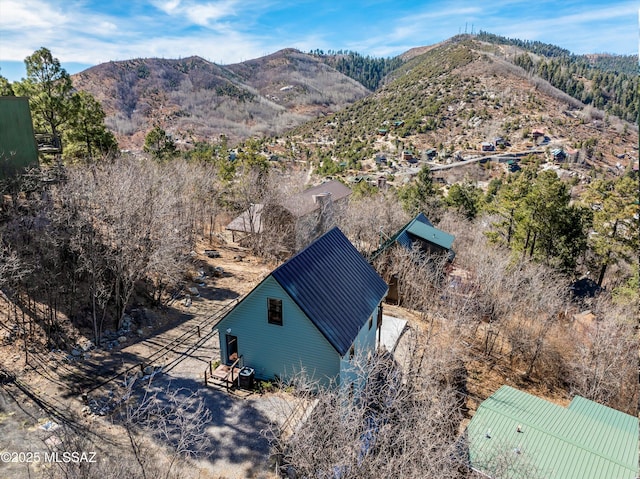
369 213 455 302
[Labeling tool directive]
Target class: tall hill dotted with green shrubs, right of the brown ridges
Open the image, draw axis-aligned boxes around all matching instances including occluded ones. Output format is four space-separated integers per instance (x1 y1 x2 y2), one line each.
289 35 637 175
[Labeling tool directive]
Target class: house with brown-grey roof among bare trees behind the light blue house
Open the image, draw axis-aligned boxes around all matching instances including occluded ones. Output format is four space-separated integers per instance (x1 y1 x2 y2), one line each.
227 180 351 252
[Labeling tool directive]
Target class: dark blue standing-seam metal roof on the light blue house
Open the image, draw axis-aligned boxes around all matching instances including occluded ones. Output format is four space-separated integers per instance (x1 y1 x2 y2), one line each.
271 228 388 356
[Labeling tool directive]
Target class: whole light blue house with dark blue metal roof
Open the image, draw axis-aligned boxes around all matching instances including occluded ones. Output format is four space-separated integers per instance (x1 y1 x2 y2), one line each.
217 228 388 386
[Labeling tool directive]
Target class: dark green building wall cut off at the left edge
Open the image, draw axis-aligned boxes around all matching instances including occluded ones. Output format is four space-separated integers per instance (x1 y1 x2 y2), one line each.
0 96 38 179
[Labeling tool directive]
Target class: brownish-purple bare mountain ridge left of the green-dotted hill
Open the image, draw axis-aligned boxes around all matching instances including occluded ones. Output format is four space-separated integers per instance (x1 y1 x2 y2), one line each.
73 49 370 149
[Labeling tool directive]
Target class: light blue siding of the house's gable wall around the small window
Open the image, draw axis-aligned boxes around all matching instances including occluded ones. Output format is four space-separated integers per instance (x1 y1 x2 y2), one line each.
218 276 340 386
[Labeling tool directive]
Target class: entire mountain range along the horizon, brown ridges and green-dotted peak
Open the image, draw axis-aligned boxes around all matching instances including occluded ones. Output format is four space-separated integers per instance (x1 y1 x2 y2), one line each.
73 36 638 158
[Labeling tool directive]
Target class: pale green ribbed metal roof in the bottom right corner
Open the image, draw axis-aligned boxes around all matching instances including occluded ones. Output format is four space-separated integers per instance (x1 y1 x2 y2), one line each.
466 386 640 479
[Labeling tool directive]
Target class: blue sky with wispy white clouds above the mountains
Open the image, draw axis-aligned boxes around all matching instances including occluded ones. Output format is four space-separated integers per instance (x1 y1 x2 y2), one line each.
0 0 640 81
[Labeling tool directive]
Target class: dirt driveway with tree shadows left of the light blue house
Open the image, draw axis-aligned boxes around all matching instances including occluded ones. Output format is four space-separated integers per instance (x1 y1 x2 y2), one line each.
0 245 284 478
